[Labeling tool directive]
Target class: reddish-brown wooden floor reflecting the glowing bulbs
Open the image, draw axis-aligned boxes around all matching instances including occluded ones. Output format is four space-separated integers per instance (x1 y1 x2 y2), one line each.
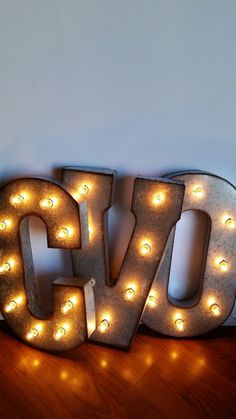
0 322 236 419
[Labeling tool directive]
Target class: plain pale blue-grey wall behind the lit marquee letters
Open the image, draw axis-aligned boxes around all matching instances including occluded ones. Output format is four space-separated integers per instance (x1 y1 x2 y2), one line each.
0 0 236 324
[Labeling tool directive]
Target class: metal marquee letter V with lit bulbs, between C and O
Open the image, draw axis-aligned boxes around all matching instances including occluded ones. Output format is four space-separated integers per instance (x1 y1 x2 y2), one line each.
63 168 184 348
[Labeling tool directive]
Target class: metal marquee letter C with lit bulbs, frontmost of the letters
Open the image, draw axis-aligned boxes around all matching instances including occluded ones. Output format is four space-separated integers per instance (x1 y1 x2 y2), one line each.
0 178 94 350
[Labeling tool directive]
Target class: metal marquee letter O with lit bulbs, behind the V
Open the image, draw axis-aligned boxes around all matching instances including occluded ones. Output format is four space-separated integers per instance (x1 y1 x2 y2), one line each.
142 172 236 337
